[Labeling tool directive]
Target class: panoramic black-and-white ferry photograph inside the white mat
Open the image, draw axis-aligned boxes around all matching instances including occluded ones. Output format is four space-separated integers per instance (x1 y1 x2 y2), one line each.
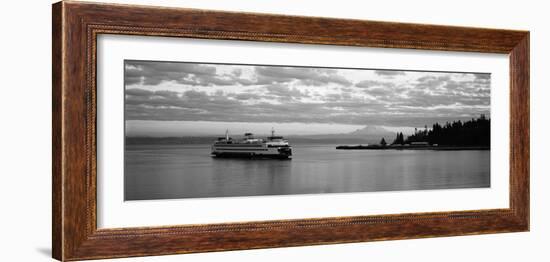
123 60 491 201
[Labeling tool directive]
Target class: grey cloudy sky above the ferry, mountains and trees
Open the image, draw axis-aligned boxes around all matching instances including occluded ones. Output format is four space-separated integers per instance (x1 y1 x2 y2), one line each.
124 60 490 136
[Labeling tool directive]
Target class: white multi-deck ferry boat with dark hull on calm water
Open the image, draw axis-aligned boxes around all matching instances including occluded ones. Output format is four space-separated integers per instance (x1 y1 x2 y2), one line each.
212 129 292 159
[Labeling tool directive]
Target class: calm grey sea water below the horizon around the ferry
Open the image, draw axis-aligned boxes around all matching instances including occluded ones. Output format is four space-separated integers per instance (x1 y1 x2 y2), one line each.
124 145 490 200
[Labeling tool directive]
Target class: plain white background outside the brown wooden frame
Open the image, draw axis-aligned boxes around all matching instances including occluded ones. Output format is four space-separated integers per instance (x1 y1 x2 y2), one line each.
0 0 550 261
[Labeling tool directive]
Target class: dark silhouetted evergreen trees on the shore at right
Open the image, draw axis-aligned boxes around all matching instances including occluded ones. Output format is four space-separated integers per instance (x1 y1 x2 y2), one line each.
390 115 491 146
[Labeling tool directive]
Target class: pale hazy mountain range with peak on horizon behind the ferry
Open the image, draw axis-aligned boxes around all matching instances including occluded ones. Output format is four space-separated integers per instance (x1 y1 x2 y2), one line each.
126 126 395 145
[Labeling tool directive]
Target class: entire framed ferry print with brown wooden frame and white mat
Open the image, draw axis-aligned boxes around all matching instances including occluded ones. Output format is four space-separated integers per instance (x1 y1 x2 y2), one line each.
52 1 529 261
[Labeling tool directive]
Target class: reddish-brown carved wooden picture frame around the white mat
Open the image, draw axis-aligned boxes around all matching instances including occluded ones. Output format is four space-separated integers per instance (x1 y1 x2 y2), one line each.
52 2 529 261
